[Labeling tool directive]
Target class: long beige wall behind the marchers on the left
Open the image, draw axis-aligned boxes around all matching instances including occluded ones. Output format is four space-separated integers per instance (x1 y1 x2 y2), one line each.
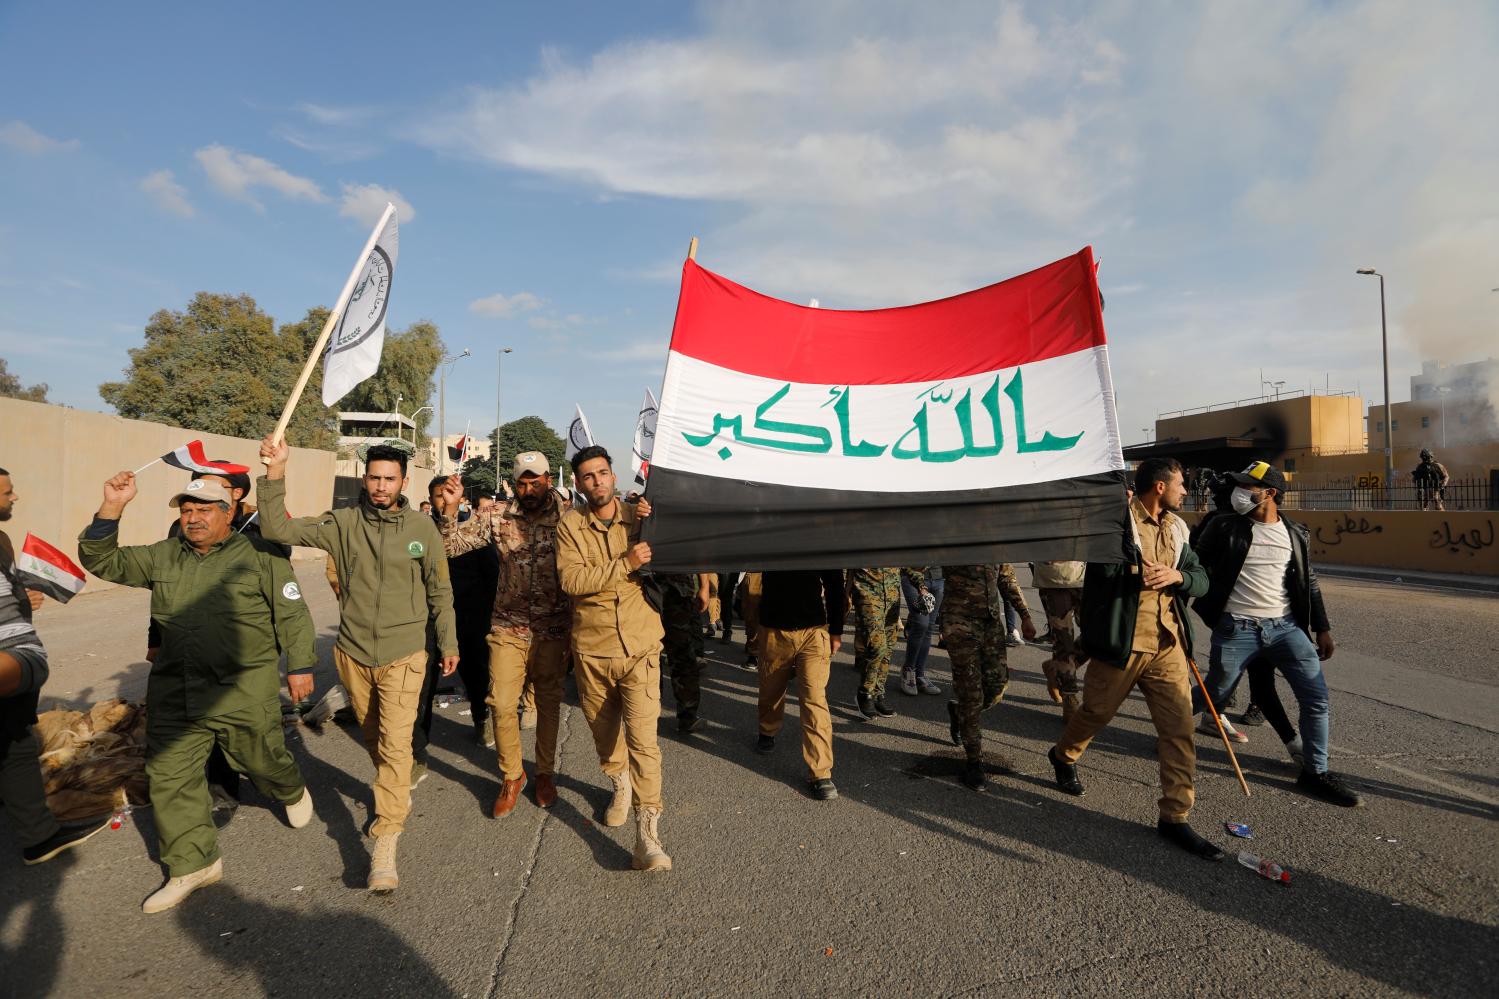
0 399 333 593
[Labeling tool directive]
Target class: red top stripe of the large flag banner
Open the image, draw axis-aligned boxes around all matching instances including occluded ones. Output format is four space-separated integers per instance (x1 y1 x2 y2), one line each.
672 246 1106 386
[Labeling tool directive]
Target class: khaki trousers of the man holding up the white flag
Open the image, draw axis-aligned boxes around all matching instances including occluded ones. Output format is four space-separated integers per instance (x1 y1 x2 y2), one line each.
333 647 427 836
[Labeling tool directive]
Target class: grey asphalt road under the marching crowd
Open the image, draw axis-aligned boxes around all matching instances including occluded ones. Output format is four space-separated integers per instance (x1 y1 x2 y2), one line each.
0 564 1499 998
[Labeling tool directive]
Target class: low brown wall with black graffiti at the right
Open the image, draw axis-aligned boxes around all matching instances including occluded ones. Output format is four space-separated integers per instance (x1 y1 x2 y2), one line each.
1183 510 1499 576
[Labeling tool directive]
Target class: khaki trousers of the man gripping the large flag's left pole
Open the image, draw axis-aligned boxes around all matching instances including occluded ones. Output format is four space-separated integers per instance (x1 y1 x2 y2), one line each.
575 648 661 809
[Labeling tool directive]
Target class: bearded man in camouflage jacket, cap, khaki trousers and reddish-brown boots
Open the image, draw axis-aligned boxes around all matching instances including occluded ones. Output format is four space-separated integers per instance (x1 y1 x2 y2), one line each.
433 452 571 819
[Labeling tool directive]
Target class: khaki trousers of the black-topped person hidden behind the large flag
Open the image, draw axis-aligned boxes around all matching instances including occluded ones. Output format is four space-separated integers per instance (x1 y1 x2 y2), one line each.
755 629 833 780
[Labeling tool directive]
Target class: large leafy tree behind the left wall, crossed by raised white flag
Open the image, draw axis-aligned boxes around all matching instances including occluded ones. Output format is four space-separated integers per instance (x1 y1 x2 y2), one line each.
99 291 442 449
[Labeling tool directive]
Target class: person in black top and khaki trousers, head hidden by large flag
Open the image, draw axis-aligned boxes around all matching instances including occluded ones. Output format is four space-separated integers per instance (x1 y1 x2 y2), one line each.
754 570 848 801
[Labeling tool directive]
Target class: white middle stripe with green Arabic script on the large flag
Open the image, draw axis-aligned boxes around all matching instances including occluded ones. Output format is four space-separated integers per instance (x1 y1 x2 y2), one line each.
652 347 1124 492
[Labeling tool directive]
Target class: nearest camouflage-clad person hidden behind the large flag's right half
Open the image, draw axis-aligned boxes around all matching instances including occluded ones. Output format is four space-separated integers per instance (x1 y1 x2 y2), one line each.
941 564 1036 791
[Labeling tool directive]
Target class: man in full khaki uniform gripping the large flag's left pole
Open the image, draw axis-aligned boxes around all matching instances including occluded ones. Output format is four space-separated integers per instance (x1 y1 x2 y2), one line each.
558 446 672 870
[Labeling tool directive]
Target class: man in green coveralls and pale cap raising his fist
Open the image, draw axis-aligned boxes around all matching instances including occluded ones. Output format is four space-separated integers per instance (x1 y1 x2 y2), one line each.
78 473 316 912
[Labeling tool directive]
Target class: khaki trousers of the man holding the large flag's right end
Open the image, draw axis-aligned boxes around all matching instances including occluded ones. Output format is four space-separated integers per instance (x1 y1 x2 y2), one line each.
1057 645 1198 822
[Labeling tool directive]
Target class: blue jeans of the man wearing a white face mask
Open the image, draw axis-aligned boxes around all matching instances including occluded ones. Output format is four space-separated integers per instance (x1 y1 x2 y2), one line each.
1192 614 1328 774
